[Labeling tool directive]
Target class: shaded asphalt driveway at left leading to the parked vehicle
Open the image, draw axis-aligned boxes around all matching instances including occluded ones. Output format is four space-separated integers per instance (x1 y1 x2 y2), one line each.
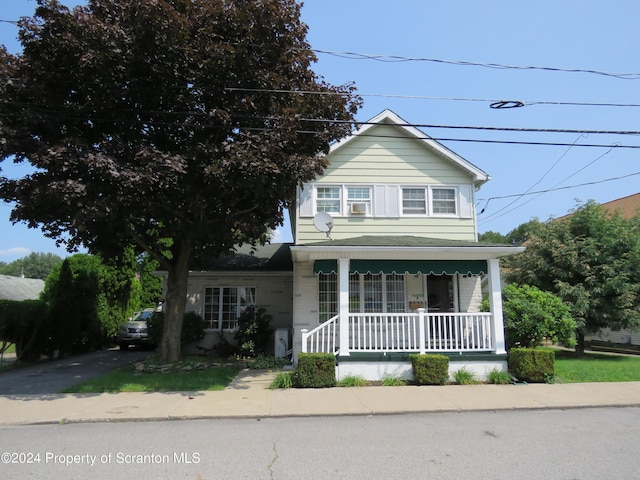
0 348 151 395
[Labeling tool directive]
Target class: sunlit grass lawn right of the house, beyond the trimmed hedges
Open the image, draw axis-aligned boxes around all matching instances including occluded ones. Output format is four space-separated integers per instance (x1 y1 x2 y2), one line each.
553 349 640 383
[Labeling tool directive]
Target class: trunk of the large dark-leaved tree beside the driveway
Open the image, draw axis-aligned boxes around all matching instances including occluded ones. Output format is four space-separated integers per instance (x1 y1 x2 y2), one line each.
158 244 191 363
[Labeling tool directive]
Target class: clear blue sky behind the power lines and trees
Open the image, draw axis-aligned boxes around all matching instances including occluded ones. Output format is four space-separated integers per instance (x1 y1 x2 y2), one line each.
0 0 640 262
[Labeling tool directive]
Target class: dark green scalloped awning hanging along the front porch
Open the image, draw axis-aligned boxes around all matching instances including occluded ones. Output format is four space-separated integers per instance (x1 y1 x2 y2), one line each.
313 260 487 275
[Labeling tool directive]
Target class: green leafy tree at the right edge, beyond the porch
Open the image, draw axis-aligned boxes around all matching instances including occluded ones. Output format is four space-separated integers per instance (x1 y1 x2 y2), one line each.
508 201 640 352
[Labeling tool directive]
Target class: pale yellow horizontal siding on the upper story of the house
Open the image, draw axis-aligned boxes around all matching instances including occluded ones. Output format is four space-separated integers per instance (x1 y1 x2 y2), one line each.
294 125 476 244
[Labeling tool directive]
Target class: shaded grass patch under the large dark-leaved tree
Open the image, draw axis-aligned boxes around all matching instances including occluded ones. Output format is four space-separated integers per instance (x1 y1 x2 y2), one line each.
62 365 240 393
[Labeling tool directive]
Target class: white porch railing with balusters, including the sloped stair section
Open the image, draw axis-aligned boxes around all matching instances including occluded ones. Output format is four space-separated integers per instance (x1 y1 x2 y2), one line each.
302 313 495 354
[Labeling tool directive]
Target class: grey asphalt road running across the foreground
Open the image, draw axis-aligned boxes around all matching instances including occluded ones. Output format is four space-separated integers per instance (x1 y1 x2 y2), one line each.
0 408 640 480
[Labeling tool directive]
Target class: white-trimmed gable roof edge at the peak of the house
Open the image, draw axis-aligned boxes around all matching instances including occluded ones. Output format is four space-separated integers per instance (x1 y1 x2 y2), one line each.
329 109 491 186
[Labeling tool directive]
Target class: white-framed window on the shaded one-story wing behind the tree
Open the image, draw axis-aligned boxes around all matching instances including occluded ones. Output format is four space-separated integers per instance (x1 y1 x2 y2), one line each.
204 287 256 330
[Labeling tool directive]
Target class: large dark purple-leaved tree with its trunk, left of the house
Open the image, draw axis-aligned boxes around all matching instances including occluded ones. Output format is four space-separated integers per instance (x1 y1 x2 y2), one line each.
0 0 361 361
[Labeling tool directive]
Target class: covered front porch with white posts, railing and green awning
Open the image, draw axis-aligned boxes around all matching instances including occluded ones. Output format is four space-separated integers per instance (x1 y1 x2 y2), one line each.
292 238 517 380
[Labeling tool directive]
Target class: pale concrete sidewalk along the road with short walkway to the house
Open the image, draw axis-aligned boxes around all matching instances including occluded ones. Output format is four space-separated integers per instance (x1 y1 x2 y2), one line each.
0 370 640 425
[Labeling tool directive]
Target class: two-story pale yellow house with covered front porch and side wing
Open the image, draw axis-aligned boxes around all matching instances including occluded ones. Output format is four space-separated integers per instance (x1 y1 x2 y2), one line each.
172 110 524 380
